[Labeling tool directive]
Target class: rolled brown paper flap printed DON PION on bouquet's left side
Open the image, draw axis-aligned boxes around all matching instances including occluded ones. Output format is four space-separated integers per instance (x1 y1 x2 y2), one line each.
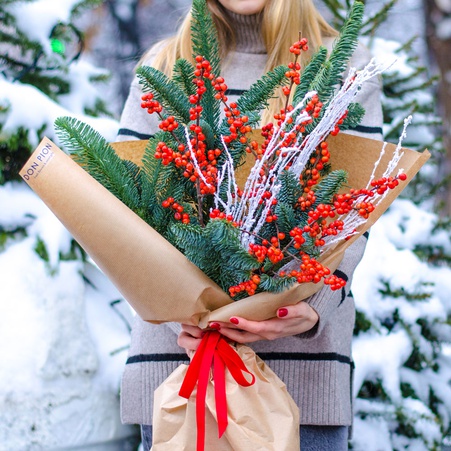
20 138 232 324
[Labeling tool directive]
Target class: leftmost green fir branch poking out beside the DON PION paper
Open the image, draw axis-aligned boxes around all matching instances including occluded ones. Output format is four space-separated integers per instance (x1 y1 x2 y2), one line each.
55 117 140 214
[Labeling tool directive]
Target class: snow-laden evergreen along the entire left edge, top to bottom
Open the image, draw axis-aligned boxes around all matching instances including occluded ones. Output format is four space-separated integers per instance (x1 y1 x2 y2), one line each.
0 0 139 451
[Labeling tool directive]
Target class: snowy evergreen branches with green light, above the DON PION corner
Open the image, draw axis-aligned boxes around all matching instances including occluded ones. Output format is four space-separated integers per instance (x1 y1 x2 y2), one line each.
0 0 115 183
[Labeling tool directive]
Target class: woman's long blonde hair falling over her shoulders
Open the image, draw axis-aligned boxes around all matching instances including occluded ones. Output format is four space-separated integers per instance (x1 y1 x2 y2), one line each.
140 0 338 123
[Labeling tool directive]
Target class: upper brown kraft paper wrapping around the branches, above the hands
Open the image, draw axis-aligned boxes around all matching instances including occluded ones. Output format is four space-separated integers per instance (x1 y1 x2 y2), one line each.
20 134 430 327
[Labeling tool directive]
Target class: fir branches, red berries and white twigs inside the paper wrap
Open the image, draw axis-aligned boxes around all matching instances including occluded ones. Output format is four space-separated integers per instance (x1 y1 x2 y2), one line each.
56 2 406 300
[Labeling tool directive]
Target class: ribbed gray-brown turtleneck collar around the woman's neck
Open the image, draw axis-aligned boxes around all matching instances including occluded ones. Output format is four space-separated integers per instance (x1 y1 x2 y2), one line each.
226 10 266 54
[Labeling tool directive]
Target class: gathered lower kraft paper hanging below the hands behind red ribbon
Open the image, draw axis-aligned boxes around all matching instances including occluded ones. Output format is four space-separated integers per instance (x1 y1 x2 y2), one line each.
152 345 299 451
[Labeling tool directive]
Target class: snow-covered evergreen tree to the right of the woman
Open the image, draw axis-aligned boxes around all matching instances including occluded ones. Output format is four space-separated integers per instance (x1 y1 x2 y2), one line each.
324 0 451 451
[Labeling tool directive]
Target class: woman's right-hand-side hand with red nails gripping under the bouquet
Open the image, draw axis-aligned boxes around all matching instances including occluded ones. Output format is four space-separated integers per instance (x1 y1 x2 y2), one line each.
210 301 319 343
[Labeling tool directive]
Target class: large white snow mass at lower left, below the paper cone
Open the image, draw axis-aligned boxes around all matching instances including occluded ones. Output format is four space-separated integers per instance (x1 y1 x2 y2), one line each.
0 183 136 450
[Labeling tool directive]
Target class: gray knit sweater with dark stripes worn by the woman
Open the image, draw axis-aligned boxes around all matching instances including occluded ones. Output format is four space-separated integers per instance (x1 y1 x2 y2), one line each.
118 9 382 426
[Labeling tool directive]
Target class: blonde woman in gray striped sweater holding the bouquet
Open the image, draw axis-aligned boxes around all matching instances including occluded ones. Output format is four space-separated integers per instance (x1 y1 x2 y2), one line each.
118 0 382 451
